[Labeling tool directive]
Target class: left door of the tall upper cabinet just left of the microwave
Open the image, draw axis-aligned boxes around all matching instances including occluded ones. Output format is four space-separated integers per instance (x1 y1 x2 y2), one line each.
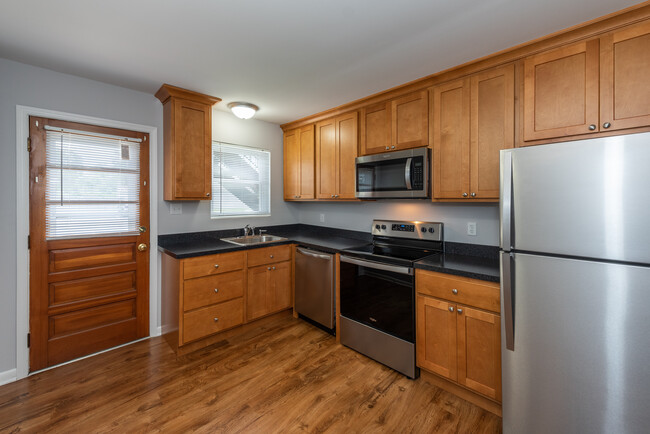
316 118 339 199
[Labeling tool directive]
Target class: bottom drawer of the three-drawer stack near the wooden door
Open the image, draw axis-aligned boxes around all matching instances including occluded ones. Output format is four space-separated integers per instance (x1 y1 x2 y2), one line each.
183 297 244 343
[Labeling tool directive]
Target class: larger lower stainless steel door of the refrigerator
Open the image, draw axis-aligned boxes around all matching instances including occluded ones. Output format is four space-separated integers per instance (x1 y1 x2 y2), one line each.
501 253 650 434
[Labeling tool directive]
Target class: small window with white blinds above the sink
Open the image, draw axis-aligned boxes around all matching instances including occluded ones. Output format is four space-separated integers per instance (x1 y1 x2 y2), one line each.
211 142 271 218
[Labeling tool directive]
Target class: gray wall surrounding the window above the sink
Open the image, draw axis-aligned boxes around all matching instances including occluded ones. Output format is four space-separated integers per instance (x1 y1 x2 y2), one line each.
158 110 298 234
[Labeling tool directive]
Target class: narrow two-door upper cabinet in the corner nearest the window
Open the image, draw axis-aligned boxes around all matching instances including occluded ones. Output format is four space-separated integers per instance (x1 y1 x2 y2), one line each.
284 124 315 200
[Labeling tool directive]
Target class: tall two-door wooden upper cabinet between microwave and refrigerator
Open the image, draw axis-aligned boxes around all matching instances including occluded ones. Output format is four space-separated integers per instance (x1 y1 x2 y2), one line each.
430 65 515 200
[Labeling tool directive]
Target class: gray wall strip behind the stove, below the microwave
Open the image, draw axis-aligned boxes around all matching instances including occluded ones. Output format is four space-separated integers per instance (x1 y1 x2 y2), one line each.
297 200 499 246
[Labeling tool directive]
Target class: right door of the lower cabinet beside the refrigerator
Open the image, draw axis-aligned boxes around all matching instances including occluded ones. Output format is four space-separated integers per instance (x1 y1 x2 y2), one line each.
456 305 501 401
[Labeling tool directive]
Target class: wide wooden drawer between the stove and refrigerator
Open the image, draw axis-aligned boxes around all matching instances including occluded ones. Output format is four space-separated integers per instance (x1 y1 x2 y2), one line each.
415 270 501 312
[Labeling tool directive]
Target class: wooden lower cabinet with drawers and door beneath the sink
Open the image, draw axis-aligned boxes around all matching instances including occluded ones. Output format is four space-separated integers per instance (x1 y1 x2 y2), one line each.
162 245 293 354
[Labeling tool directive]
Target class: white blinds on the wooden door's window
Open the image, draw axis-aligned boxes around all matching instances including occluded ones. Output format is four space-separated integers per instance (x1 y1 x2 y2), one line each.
45 127 140 239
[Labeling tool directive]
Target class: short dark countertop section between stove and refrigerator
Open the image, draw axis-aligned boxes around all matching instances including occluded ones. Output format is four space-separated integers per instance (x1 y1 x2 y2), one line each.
415 243 501 282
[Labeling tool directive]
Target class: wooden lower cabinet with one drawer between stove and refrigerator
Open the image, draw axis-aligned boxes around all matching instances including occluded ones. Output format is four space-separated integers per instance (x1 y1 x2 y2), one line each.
416 270 501 402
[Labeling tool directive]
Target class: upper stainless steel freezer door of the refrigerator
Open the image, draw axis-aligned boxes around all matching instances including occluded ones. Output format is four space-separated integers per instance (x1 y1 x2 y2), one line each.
501 133 650 264
